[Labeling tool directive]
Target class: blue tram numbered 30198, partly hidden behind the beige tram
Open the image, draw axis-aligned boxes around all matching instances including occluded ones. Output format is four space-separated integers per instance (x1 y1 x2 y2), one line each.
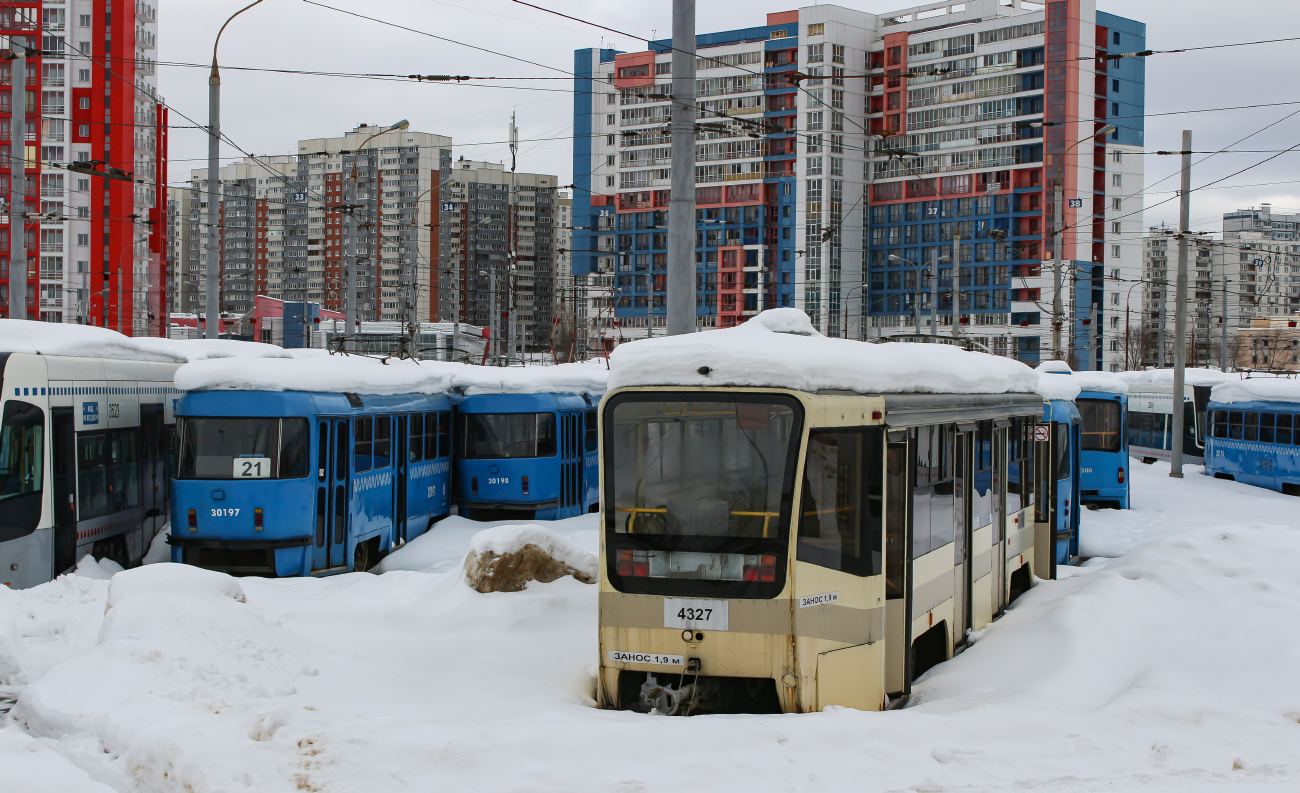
454 393 601 520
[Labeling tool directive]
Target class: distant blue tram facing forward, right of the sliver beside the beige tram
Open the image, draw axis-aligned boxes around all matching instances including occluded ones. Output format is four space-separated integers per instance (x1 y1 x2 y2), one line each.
1075 387 1128 510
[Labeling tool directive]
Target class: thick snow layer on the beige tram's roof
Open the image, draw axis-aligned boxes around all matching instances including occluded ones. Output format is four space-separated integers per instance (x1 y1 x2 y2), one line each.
610 308 1039 394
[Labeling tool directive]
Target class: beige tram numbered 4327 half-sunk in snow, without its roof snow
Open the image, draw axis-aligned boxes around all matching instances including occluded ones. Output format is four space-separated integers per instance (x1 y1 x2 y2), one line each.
598 379 1045 715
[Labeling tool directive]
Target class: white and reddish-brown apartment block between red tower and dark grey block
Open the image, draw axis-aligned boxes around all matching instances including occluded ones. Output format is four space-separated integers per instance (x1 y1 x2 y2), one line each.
181 125 451 321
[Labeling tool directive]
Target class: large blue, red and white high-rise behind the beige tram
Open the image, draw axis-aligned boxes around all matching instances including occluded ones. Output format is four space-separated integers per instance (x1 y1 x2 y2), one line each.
573 0 1145 369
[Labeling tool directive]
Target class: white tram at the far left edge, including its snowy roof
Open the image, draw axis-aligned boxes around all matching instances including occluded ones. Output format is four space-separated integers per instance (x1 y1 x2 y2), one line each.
0 320 286 589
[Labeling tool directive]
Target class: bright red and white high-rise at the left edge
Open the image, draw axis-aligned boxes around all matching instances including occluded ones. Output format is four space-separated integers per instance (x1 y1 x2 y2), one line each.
0 0 168 335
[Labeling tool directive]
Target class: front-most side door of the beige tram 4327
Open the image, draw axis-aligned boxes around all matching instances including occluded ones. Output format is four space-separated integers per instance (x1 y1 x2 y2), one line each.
884 430 913 697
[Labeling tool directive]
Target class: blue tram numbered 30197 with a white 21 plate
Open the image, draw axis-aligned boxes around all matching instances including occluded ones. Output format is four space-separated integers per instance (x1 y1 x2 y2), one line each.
168 391 451 576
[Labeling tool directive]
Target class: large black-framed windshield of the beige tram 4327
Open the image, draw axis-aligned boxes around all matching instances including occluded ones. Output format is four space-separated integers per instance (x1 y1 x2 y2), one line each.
602 393 802 598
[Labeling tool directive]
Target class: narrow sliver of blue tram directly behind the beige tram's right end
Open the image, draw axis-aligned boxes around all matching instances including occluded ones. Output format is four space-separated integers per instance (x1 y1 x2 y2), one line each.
1034 399 1083 579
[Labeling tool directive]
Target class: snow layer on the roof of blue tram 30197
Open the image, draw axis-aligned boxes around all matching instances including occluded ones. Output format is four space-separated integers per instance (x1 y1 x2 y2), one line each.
176 355 455 394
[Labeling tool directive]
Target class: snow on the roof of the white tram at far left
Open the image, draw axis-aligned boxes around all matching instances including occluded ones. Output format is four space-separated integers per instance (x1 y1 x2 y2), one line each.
0 320 287 364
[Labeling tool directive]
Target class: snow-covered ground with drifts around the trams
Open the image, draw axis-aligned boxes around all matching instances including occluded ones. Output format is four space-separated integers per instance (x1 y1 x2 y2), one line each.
0 464 1300 793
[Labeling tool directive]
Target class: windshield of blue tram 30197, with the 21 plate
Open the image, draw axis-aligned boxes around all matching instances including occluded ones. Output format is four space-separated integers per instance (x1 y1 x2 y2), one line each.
177 416 311 480
